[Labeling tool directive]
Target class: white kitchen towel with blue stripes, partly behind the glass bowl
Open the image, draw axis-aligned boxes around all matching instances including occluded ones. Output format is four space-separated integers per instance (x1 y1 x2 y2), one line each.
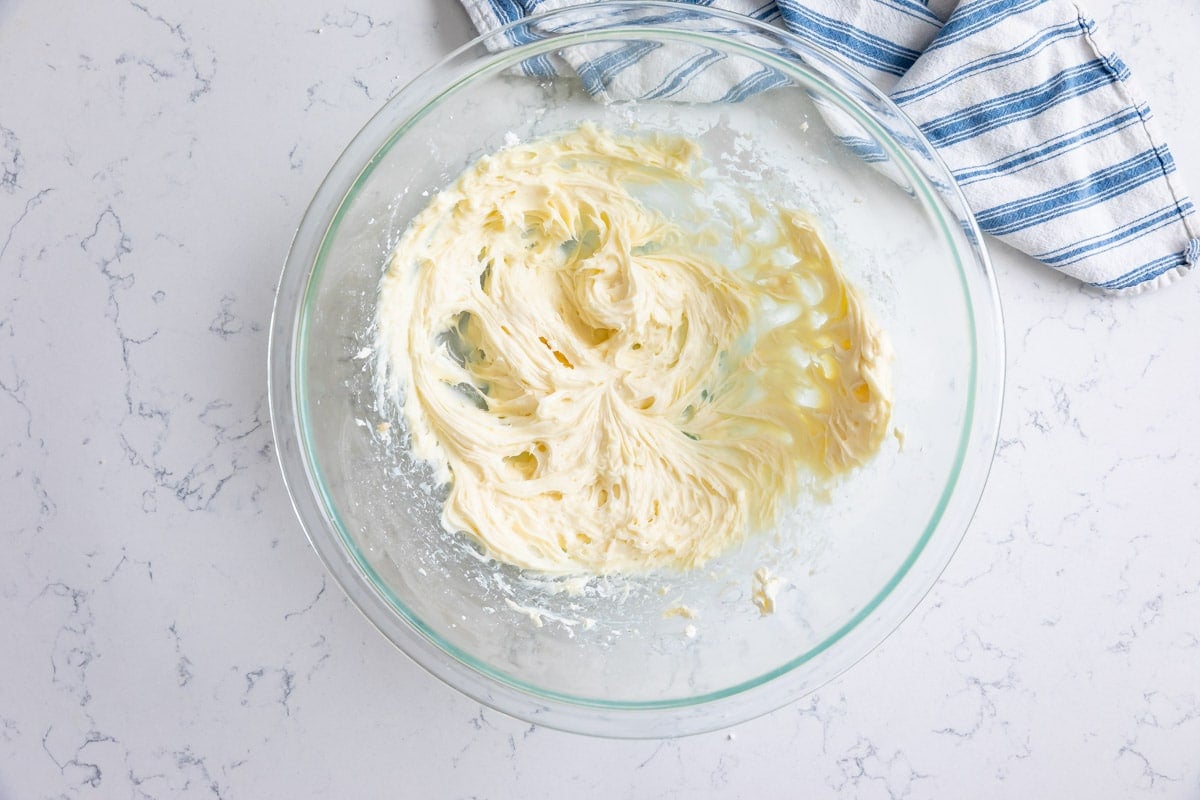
453 0 1200 291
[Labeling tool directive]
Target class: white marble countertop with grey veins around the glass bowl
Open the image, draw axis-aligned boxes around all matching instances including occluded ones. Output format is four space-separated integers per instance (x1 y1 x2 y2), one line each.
0 0 1200 800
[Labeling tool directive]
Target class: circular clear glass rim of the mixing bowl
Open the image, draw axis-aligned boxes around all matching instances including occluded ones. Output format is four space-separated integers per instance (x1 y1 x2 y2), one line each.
268 0 1004 738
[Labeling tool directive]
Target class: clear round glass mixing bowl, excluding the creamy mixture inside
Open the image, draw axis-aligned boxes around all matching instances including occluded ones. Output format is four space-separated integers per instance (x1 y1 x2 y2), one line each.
270 2 1003 736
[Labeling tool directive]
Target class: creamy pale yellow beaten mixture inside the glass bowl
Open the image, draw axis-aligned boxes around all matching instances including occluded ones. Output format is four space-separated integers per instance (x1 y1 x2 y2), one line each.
377 125 892 573
